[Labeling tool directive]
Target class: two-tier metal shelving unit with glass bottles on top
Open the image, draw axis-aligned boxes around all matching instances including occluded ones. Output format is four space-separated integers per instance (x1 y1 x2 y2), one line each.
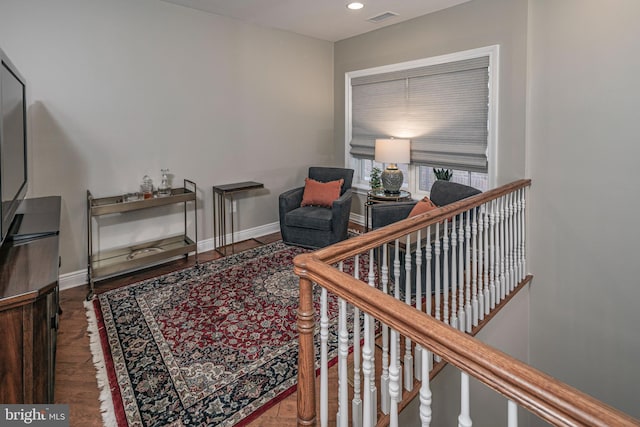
87 179 198 300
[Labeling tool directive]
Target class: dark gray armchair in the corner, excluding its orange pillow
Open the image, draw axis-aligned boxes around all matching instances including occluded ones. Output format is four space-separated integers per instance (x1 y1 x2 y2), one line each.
278 167 353 249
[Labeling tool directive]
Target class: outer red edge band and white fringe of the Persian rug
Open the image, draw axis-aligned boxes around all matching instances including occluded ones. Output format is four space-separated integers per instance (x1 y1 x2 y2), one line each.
84 241 360 426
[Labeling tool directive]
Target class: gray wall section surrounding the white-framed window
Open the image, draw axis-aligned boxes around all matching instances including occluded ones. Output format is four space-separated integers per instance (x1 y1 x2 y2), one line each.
334 0 527 216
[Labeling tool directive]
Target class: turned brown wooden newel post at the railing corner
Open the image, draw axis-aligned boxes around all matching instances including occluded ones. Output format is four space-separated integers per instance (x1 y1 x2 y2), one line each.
298 277 316 427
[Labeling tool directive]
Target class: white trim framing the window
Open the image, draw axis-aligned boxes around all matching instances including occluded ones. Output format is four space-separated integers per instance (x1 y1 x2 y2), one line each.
344 45 500 196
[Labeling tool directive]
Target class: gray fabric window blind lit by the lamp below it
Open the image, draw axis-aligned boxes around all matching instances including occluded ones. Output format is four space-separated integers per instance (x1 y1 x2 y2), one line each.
350 56 489 172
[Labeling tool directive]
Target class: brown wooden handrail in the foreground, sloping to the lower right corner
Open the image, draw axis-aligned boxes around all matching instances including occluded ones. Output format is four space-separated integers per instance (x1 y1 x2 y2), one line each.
295 253 640 427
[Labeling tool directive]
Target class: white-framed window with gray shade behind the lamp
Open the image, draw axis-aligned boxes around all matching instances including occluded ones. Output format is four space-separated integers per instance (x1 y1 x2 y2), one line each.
345 46 498 196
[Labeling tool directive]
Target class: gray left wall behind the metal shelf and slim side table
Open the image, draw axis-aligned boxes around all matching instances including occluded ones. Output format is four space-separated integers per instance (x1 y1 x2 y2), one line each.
0 0 336 277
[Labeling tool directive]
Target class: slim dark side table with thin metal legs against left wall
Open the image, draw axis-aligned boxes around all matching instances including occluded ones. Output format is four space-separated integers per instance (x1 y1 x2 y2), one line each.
213 181 264 256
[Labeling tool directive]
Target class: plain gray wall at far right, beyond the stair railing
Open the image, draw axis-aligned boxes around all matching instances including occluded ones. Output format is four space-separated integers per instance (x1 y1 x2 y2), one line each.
527 0 640 418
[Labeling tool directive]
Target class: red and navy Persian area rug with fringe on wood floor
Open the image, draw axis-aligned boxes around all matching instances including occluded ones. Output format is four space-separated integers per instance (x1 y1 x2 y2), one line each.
86 242 368 426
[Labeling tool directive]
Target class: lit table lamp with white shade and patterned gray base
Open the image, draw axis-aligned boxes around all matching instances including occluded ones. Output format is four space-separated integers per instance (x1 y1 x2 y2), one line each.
375 139 411 194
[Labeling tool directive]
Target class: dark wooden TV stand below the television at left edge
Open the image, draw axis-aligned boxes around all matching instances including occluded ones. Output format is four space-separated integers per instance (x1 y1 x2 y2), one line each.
0 196 60 404
